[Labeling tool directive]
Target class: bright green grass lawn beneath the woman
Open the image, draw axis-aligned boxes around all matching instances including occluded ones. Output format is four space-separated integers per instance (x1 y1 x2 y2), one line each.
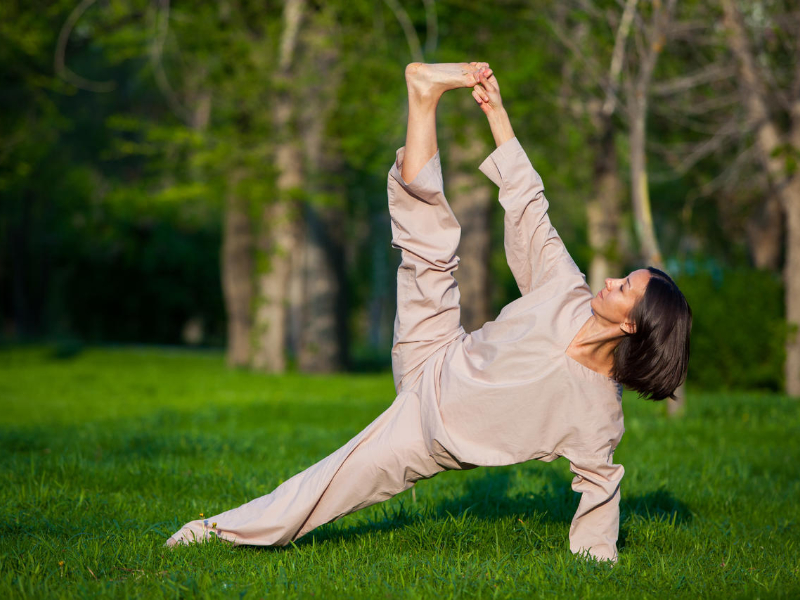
0 348 800 598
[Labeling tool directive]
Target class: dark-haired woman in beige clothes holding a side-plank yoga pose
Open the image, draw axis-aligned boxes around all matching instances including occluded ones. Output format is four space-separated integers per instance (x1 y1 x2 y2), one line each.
167 63 691 561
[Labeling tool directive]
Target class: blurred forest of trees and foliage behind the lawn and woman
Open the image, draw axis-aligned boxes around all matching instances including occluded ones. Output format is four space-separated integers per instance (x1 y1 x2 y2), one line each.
0 0 800 395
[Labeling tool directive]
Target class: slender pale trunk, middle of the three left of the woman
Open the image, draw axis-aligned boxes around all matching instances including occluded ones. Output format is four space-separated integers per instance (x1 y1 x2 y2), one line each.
251 0 305 372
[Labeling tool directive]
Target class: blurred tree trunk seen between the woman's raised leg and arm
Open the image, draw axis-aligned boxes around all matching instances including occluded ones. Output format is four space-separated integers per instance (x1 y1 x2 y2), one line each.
445 121 493 332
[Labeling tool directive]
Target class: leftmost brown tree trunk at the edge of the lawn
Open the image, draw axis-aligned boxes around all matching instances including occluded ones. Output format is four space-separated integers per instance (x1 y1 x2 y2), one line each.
221 170 254 367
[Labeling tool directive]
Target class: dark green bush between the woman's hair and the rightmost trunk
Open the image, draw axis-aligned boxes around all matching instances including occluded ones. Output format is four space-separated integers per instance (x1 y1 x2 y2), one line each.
677 268 788 391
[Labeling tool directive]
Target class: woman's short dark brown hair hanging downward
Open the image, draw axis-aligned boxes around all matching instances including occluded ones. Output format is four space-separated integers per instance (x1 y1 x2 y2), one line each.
612 267 692 400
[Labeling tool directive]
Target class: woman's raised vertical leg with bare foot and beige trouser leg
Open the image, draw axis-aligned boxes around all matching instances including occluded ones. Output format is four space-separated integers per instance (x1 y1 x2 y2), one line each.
388 63 488 392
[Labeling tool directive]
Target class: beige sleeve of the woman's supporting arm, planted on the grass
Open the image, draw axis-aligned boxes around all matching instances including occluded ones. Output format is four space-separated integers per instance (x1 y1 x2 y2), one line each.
567 455 625 561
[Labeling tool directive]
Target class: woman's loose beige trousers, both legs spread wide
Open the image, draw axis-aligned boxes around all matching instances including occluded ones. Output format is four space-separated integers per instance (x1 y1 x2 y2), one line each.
167 149 470 546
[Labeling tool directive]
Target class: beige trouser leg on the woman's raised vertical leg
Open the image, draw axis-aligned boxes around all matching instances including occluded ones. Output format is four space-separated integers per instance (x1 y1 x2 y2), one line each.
388 148 465 392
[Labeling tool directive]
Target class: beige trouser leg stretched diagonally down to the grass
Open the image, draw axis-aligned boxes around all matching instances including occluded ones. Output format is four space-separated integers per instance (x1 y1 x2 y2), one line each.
168 393 444 546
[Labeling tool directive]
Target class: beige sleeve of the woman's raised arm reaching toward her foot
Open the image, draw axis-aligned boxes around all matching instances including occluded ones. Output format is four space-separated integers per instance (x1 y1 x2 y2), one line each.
480 138 582 296
